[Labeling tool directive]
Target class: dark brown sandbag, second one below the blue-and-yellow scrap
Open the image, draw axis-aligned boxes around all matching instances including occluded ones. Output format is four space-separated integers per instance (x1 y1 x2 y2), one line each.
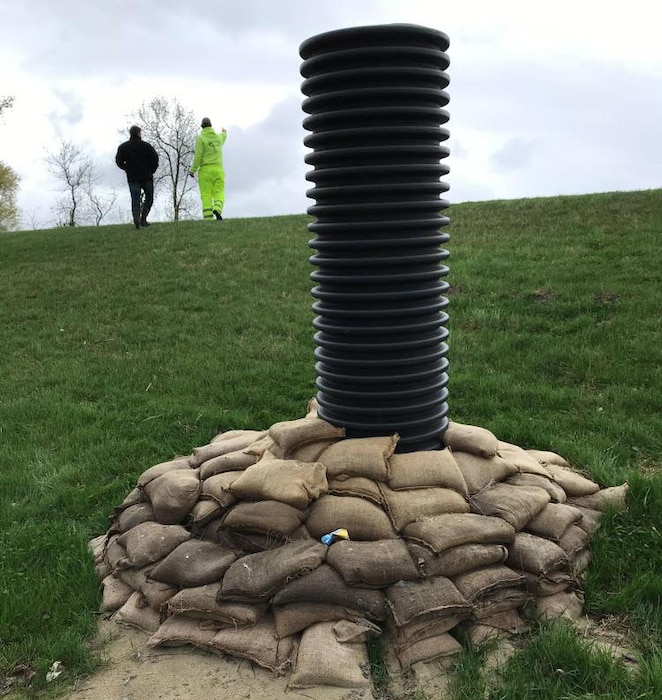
272 560 386 620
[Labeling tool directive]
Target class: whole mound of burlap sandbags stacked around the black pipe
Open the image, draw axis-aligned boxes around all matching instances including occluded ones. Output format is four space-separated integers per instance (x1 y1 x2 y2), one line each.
90 402 627 688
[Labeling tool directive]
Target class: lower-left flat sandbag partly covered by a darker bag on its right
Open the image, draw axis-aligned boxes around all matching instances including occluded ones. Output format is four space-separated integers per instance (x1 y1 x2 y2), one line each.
166 583 267 627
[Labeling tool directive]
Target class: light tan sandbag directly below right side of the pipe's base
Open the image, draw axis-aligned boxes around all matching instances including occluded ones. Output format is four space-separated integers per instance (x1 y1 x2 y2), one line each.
388 447 468 496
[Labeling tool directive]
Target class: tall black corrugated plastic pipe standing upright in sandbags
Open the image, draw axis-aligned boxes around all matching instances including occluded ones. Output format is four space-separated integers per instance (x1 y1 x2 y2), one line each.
300 24 449 452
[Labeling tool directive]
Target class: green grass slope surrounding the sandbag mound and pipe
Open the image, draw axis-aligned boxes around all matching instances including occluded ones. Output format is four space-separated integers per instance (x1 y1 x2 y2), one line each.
0 191 662 700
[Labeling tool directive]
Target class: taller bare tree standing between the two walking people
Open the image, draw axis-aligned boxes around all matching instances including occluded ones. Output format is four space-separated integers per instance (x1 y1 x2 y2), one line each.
132 96 197 221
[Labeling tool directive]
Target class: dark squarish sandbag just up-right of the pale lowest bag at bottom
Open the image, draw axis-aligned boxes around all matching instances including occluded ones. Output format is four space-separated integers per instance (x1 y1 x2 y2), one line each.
385 576 471 627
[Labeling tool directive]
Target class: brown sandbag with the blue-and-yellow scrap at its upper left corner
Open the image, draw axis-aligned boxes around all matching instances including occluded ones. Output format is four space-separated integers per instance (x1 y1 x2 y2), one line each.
326 539 420 588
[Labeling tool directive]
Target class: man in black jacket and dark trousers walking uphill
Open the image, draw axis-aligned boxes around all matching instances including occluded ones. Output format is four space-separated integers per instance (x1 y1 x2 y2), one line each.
115 126 159 228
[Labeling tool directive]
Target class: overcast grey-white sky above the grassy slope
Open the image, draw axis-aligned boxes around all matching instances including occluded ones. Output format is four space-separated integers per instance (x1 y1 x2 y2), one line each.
0 0 662 228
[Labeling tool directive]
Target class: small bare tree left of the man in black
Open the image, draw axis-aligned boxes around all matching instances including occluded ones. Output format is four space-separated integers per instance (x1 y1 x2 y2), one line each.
46 141 97 226
